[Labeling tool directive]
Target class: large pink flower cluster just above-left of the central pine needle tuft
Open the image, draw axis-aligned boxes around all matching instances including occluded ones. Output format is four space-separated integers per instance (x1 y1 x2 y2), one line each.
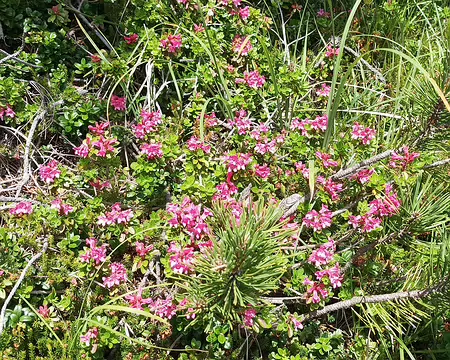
167 197 213 242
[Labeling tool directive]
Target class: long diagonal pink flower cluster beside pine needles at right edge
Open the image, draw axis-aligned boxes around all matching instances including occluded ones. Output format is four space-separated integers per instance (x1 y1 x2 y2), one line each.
348 184 401 232
